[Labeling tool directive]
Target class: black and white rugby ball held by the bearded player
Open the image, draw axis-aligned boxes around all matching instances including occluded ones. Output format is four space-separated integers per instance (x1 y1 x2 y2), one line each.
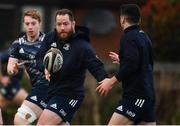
43 48 63 73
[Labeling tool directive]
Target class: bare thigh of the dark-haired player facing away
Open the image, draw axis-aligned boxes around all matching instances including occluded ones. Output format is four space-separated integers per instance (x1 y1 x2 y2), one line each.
108 112 133 125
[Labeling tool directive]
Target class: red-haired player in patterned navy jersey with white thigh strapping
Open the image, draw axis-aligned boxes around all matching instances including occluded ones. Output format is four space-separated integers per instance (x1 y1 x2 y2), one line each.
7 10 48 125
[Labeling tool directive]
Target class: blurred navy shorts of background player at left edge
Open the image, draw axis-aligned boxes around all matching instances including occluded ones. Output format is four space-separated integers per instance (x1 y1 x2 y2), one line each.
0 78 20 100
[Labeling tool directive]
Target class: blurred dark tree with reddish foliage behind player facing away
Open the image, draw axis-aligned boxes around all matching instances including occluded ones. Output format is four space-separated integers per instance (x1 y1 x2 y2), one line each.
142 0 180 62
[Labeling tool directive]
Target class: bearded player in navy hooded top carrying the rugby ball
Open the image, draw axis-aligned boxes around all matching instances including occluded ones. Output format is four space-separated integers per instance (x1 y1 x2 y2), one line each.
37 9 107 125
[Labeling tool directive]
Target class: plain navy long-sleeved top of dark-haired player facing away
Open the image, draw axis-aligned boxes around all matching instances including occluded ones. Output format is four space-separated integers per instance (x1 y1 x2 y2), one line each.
116 25 155 100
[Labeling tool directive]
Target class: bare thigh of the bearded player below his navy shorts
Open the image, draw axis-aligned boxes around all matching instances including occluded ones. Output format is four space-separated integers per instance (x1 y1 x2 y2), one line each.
37 109 62 125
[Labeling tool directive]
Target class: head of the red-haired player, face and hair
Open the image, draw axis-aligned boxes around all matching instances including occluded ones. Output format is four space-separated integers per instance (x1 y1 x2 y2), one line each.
23 10 41 38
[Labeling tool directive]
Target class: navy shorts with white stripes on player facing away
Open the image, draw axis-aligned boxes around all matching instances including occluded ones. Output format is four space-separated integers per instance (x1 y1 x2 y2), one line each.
115 96 156 124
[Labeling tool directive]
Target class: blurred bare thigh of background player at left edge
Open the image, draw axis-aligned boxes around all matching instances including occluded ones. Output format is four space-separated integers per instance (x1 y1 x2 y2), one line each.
13 88 28 105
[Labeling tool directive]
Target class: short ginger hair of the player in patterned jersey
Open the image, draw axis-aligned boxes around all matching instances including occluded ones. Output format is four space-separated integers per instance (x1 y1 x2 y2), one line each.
23 10 41 22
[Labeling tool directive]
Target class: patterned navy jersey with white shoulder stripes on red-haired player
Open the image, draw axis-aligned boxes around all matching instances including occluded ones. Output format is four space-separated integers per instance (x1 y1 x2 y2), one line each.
9 33 48 87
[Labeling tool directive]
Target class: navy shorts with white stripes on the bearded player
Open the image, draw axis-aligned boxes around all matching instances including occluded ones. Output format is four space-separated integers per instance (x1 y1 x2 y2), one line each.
46 96 83 123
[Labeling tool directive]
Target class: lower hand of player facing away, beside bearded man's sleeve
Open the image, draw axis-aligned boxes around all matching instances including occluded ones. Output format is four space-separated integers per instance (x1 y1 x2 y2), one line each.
96 78 113 96
